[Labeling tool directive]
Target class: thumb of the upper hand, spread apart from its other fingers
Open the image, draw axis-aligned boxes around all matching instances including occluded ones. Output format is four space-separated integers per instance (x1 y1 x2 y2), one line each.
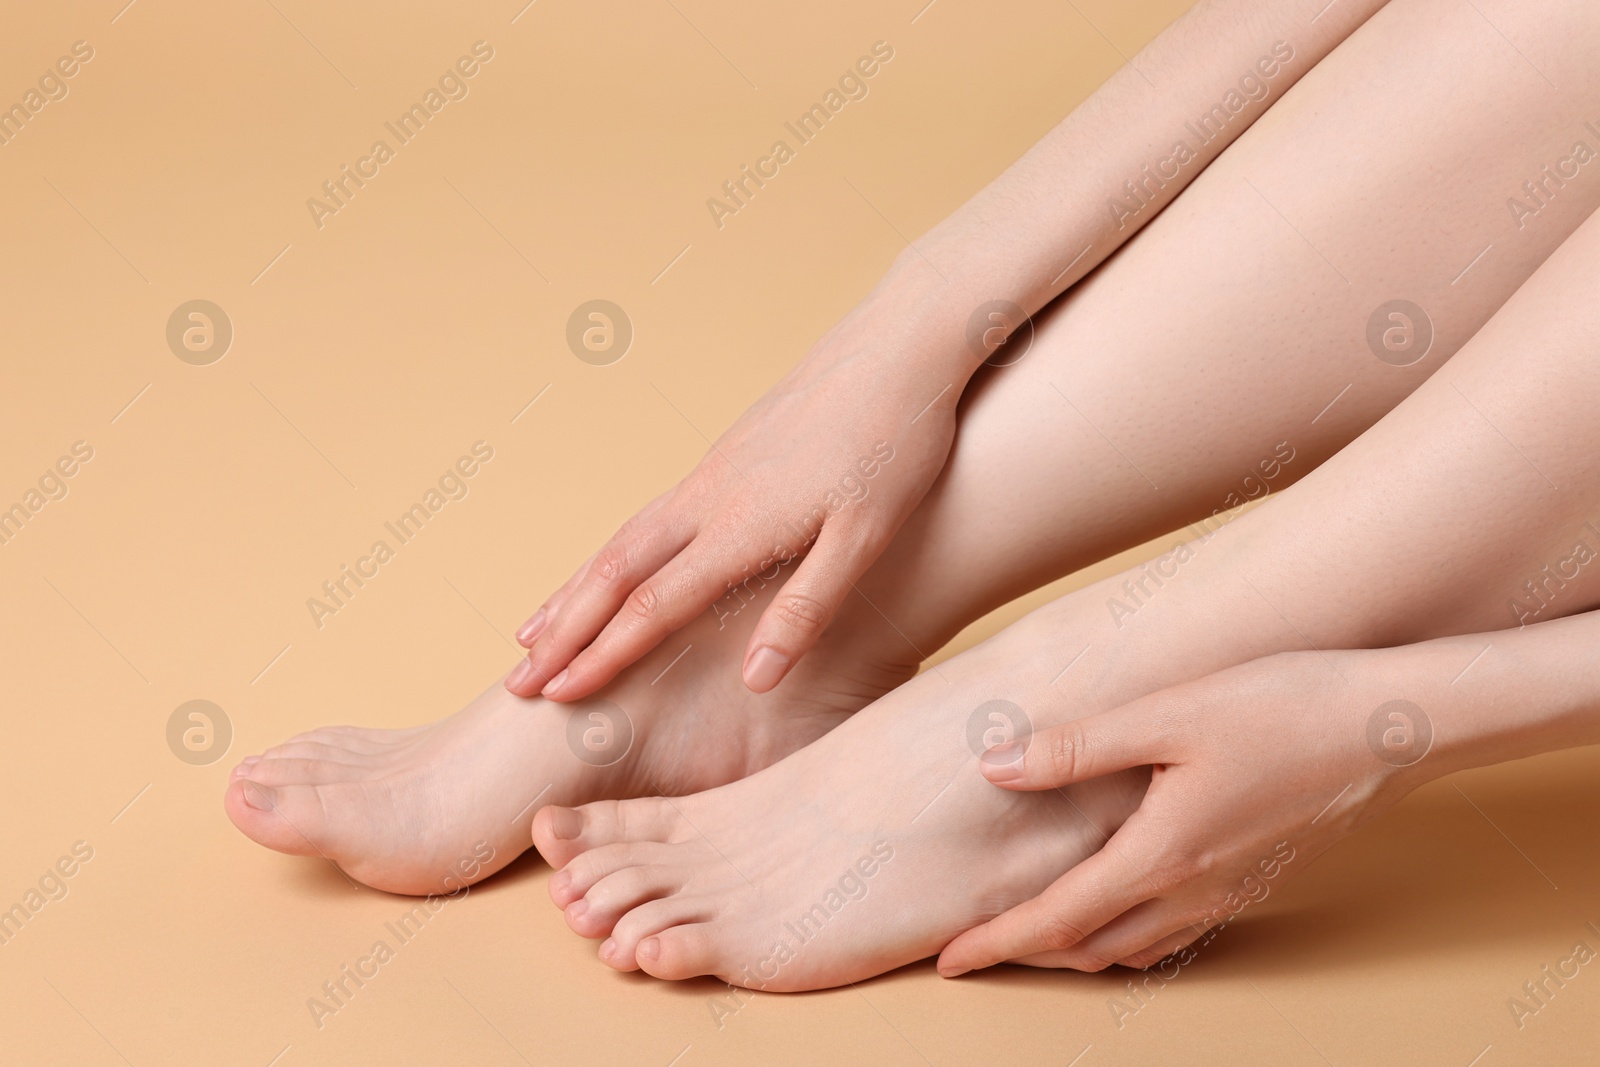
744 522 883 693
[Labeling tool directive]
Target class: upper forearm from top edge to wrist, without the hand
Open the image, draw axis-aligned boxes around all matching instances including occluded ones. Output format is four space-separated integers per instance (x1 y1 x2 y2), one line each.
866 0 1386 382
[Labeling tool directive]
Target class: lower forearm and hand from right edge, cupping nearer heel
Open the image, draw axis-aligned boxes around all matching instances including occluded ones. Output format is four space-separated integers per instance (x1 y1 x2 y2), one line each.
939 607 1600 977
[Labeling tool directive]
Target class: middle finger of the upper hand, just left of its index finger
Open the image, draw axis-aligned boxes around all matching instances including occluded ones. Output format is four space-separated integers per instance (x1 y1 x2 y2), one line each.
510 514 694 696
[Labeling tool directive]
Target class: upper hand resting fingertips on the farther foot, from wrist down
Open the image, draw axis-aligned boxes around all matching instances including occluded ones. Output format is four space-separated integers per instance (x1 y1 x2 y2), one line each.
506 310 984 701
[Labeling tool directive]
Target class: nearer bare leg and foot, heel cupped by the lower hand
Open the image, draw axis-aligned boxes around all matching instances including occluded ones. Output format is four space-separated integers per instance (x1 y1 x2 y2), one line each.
534 137 1600 989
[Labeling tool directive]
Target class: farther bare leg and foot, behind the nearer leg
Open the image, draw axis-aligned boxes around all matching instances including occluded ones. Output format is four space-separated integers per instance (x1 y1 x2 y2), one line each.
226 3 1600 893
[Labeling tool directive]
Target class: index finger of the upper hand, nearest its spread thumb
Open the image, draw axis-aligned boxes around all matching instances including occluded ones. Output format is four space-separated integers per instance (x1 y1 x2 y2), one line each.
544 531 771 701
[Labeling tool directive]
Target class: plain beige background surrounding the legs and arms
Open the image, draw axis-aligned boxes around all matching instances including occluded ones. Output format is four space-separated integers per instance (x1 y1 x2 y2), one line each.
0 0 1600 1067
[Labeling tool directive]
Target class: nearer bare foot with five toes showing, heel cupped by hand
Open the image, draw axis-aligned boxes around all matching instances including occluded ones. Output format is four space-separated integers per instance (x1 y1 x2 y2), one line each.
534 601 1149 990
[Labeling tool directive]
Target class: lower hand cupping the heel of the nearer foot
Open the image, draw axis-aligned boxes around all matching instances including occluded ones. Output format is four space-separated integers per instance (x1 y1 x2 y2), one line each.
939 648 1440 977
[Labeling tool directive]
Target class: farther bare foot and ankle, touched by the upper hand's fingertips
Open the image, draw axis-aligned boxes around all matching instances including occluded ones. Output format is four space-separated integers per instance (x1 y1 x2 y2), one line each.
224 579 918 894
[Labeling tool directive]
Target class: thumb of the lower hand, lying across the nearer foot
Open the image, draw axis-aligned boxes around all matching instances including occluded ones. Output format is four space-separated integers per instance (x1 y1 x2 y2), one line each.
978 697 1173 789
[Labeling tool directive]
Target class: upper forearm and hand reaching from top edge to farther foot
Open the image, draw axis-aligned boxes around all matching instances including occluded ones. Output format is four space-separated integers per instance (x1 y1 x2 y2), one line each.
506 0 1384 701
